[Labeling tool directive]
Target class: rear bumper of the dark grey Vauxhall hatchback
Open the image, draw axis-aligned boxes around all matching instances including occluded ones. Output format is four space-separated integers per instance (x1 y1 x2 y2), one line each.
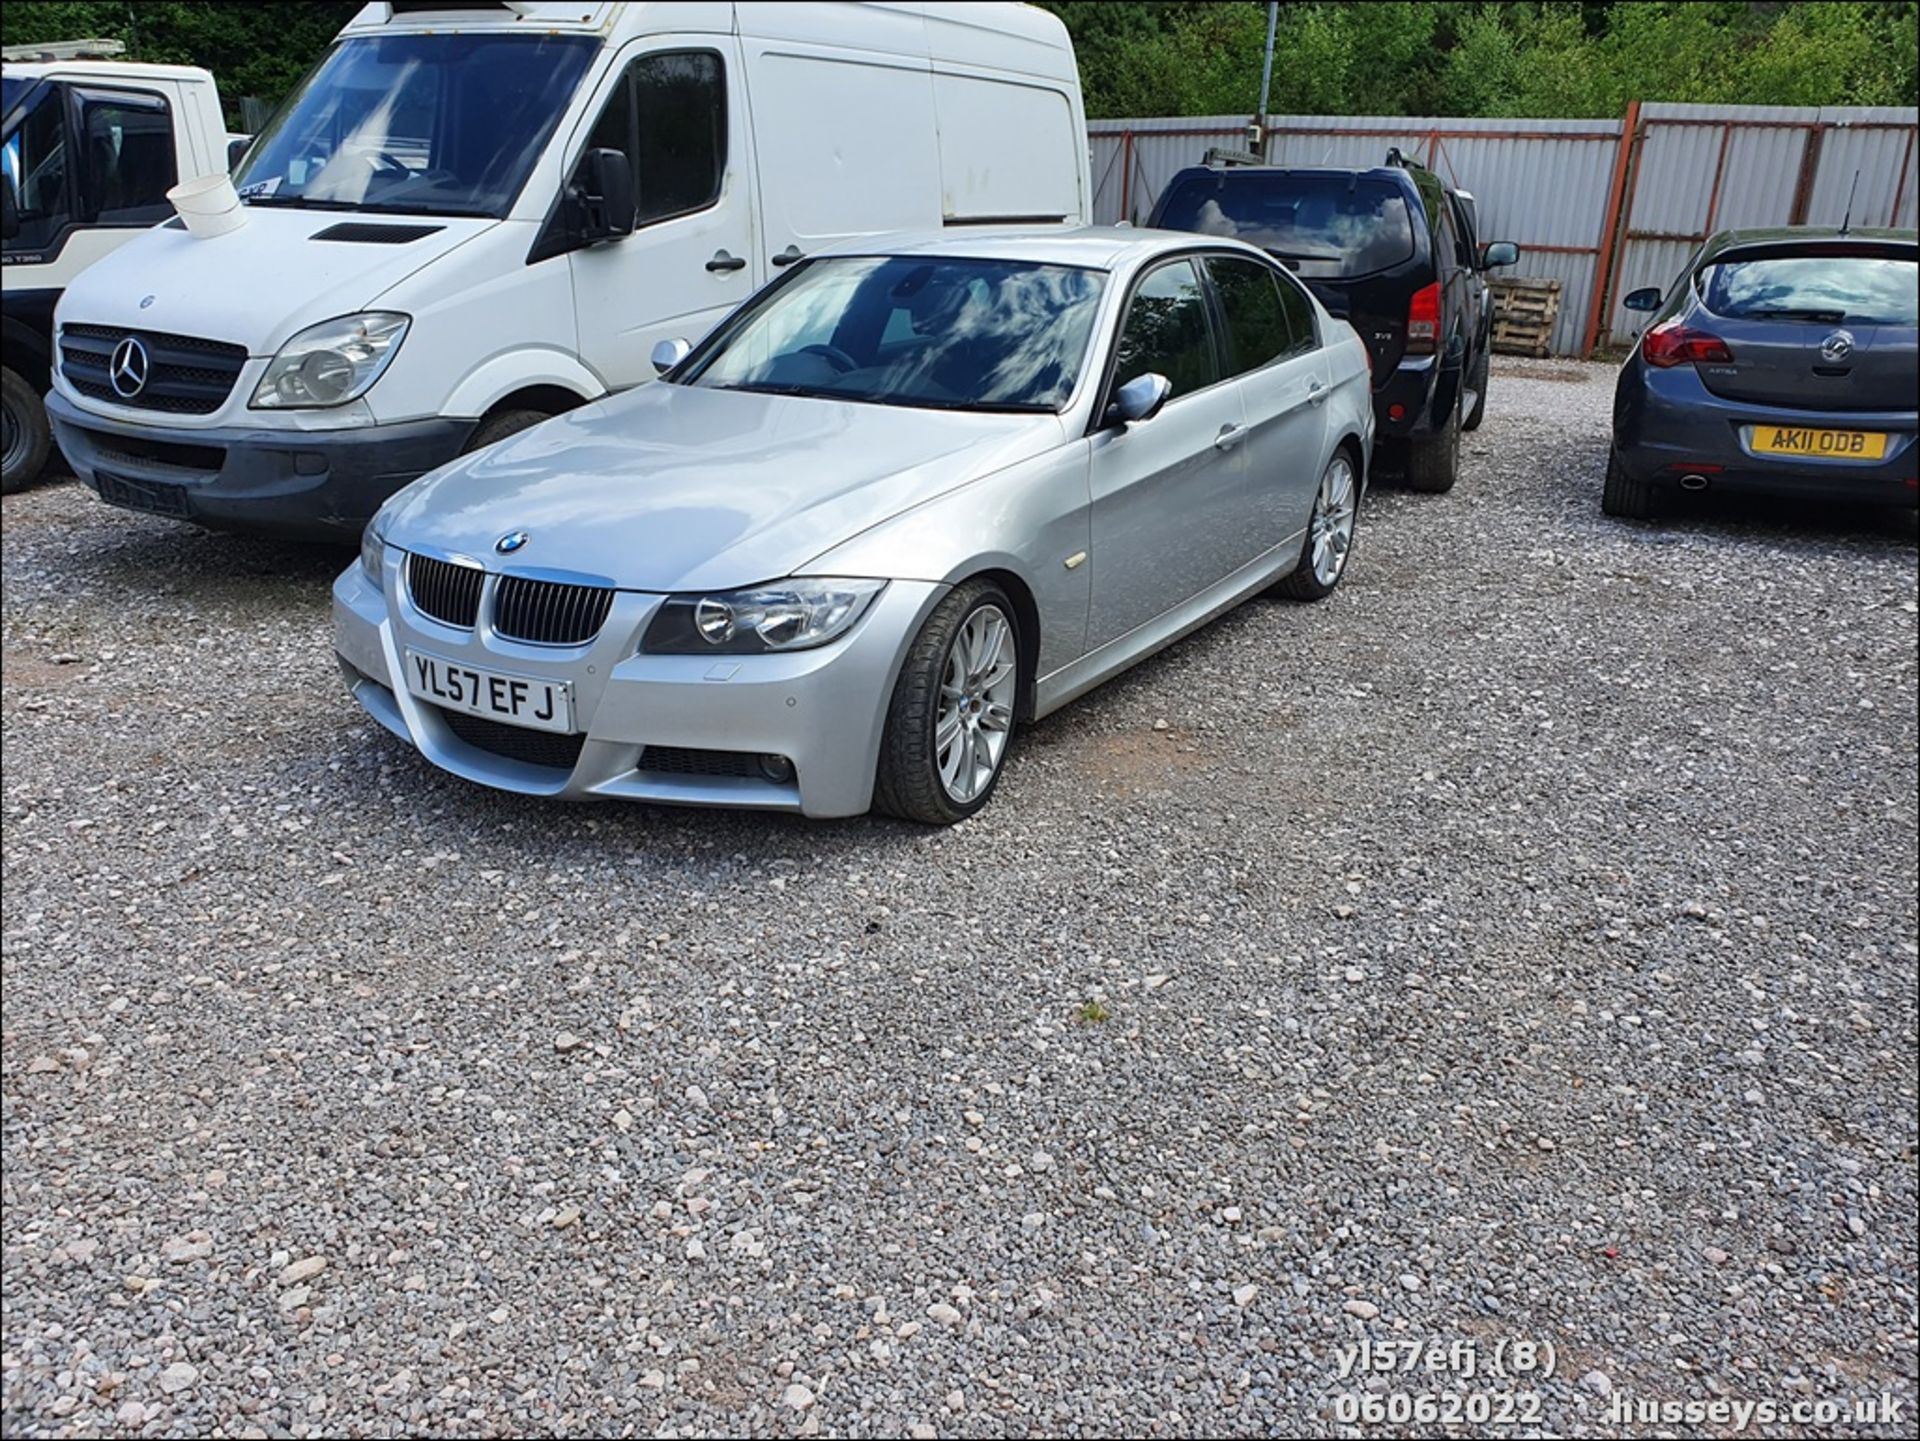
1613 366 1920 507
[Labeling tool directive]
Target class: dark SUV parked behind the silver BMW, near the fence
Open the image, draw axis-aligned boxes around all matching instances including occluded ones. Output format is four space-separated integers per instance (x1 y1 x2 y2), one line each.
1148 152 1519 491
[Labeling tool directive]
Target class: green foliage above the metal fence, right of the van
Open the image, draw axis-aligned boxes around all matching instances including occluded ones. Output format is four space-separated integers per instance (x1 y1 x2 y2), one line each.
1043 0 1920 117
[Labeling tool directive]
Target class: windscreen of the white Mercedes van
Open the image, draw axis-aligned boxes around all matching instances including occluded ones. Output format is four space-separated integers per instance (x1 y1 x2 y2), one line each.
234 33 599 219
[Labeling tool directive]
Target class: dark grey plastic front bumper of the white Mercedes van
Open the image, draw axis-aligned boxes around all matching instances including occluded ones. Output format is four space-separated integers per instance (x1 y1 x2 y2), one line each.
46 391 478 543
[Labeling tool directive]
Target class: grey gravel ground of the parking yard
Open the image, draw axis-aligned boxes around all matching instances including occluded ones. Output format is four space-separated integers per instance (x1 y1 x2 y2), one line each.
0 363 1920 1437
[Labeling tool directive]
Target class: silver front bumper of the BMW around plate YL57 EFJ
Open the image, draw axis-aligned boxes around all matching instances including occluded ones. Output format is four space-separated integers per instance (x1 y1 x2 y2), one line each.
334 547 947 815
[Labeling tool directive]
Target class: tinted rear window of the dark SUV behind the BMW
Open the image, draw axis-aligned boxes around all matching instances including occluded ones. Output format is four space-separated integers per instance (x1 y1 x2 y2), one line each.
1158 173 1415 280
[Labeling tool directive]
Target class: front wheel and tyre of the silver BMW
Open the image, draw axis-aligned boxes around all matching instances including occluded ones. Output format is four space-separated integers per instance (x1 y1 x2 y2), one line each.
874 579 1021 825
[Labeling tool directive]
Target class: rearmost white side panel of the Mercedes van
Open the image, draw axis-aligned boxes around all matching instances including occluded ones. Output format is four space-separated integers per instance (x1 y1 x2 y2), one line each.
933 75 1081 221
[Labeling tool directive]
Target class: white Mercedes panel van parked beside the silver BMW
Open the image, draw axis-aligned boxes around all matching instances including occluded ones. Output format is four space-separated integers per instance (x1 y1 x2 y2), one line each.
48 0 1091 539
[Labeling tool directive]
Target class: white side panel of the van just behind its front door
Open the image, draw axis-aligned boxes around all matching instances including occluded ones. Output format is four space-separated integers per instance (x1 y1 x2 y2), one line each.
749 48 940 253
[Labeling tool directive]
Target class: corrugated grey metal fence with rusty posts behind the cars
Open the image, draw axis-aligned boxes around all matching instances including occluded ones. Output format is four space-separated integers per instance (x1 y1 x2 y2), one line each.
1087 104 1920 355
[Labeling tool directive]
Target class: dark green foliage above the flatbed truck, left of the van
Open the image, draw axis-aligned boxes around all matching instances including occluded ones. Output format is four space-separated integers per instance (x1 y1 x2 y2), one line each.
6 0 359 129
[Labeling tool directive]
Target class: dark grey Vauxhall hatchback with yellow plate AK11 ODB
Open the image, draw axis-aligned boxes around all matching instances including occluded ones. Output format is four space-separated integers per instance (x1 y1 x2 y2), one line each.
1601 226 1920 518
